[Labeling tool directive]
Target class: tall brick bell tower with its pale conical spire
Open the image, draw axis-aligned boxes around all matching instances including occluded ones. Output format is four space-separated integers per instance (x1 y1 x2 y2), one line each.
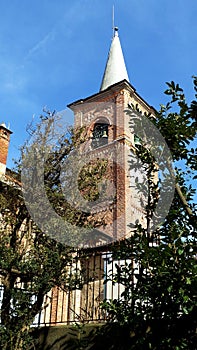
68 27 154 243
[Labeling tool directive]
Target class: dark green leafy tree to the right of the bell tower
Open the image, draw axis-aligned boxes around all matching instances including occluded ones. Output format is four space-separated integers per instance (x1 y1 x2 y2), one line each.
103 77 197 350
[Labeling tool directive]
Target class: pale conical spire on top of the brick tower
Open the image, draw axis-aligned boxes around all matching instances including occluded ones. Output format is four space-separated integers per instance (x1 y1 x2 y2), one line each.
100 27 129 91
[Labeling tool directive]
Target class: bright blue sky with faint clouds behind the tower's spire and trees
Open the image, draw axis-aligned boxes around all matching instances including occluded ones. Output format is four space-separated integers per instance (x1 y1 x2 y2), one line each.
0 0 197 167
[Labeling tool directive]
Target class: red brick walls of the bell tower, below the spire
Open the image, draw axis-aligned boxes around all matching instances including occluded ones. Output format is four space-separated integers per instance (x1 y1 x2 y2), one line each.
69 84 155 245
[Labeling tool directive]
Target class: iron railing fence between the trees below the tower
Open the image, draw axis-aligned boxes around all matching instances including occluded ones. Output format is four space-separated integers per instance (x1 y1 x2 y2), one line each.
0 249 137 326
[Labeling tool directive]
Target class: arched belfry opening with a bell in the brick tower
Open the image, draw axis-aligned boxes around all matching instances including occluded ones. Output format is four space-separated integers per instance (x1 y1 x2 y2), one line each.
92 123 109 148
